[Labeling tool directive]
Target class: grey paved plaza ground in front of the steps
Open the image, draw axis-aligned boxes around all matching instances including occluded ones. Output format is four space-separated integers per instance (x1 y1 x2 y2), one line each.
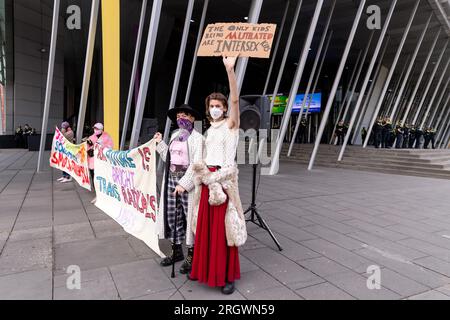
0 150 450 300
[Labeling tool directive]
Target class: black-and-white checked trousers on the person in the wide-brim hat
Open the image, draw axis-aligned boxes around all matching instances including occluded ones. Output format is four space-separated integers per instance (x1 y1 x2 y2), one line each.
166 172 188 244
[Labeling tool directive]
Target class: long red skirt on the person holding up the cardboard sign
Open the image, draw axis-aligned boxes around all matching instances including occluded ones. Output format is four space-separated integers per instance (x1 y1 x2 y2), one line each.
191 185 241 287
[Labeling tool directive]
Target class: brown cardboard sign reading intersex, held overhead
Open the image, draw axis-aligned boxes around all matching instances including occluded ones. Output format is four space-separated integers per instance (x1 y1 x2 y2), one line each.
197 22 276 58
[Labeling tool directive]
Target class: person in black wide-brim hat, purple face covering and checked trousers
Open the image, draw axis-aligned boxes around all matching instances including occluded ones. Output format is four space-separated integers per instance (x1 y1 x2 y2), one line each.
153 104 204 274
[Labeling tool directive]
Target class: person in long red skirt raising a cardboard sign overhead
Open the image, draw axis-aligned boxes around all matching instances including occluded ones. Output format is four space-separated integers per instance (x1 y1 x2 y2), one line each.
188 57 247 294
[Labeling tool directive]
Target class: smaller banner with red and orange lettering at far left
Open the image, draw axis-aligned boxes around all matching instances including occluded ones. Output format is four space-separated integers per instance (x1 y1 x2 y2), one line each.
50 128 91 190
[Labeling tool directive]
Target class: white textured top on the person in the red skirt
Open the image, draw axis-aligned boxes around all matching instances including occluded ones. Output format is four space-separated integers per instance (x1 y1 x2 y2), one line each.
204 119 239 167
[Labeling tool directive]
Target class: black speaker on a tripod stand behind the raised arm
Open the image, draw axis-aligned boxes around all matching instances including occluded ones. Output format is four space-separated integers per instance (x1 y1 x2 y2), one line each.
239 95 270 131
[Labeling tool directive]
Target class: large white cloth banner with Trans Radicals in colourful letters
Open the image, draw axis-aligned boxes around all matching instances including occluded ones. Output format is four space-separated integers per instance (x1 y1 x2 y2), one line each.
94 140 164 257
